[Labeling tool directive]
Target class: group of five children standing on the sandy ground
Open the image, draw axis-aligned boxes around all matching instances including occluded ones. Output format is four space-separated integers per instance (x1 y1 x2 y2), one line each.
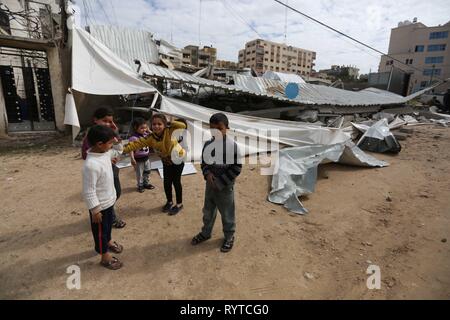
82 108 242 270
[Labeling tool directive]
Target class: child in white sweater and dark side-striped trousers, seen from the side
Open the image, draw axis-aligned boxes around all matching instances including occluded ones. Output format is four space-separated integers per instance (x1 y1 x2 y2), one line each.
83 125 123 270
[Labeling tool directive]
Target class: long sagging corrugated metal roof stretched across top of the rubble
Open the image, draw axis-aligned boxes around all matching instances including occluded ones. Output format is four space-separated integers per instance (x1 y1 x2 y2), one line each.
141 64 436 106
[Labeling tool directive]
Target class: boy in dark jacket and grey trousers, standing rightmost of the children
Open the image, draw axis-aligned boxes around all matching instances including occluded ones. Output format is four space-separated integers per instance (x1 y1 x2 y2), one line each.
191 113 242 252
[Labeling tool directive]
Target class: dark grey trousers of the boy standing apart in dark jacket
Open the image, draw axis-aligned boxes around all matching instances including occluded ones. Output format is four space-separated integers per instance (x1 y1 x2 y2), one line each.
201 183 236 240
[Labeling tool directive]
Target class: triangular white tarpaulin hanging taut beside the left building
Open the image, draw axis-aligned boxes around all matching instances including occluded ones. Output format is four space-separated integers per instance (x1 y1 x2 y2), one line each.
72 28 156 95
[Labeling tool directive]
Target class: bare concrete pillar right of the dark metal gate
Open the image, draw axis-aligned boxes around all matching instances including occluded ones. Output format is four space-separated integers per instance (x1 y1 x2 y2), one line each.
47 47 67 131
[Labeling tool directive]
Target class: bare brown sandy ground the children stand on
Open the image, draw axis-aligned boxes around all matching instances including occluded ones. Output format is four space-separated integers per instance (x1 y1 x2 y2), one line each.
0 126 450 299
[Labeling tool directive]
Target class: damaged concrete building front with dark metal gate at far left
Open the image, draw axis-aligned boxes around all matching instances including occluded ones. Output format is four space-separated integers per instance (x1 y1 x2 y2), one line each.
0 0 70 135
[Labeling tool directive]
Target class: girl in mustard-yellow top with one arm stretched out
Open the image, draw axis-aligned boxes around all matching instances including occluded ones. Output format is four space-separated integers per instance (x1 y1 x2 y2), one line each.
123 113 186 215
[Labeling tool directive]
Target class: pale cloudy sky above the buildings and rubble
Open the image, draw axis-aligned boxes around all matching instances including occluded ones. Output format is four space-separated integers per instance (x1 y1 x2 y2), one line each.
75 0 450 73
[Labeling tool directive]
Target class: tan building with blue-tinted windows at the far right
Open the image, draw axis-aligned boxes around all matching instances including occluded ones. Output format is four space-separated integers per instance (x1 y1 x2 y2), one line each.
378 19 450 94
